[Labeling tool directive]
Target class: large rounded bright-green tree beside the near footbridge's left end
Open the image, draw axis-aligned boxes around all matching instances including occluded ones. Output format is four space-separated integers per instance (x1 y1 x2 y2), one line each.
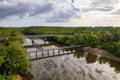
8 41 30 74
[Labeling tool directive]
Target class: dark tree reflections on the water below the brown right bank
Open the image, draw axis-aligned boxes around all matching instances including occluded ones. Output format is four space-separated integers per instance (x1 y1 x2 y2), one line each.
73 51 120 73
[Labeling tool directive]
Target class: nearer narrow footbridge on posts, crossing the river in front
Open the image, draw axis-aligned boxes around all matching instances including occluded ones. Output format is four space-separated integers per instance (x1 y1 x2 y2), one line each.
29 45 86 60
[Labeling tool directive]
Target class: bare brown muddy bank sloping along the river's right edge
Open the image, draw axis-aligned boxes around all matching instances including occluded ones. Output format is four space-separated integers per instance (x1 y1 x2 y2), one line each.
82 47 120 62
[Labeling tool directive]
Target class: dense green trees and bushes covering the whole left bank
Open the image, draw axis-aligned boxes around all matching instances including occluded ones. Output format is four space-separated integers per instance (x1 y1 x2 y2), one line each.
0 28 30 80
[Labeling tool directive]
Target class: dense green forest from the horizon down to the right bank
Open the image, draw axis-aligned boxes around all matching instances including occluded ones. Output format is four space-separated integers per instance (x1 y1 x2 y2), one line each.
21 27 120 57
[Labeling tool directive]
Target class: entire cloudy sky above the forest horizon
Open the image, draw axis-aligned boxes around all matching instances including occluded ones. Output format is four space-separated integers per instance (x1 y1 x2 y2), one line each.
0 0 120 27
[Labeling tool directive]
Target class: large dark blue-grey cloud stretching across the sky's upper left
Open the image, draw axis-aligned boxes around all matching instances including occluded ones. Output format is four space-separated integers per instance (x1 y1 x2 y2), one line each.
0 0 52 19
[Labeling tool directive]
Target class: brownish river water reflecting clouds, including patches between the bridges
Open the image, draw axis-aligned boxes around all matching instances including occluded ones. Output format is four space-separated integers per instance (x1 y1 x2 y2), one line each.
24 39 120 80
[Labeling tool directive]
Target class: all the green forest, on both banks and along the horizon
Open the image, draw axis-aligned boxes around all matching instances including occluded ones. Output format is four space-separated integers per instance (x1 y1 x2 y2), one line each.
0 26 120 80
